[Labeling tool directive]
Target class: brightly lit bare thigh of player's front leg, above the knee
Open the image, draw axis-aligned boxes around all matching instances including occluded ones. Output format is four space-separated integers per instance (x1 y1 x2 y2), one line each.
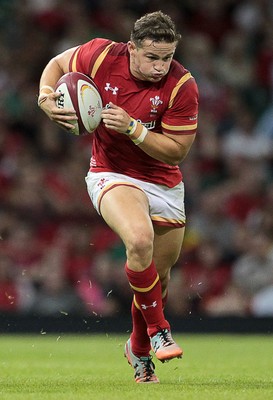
100 185 154 244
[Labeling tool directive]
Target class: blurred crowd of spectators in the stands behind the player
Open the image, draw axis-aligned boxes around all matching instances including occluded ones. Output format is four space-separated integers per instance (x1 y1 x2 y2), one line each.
0 0 273 317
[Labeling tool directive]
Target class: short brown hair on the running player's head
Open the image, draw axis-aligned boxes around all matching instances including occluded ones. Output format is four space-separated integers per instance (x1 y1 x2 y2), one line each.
131 11 181 47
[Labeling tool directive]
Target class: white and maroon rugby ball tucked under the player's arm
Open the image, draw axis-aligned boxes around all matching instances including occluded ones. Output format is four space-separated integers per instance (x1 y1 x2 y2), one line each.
55 72 102 135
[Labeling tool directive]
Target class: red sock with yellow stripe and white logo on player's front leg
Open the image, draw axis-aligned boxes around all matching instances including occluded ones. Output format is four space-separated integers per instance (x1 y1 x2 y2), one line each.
125 262 170 336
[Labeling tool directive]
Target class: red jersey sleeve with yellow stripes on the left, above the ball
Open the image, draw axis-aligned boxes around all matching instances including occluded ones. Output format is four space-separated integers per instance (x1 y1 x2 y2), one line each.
69 38 115 78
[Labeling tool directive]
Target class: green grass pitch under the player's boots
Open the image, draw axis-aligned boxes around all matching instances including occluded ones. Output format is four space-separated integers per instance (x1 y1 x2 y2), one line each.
0 334 273 400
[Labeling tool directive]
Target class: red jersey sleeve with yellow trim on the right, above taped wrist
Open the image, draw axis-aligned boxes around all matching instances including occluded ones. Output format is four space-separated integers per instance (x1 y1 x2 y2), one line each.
161 73 199 135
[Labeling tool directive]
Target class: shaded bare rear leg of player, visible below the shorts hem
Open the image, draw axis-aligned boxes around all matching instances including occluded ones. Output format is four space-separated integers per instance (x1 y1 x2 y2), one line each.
153 226 185 278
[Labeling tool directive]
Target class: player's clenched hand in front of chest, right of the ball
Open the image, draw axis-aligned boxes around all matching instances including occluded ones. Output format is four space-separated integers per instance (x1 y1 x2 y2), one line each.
101 102 131 134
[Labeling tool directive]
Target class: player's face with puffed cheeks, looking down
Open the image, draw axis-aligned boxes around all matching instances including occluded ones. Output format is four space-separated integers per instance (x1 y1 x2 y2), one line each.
128 40 176 82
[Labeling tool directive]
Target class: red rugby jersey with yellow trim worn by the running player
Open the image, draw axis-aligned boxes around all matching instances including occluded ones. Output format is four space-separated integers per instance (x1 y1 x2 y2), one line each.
70 39 198 187
